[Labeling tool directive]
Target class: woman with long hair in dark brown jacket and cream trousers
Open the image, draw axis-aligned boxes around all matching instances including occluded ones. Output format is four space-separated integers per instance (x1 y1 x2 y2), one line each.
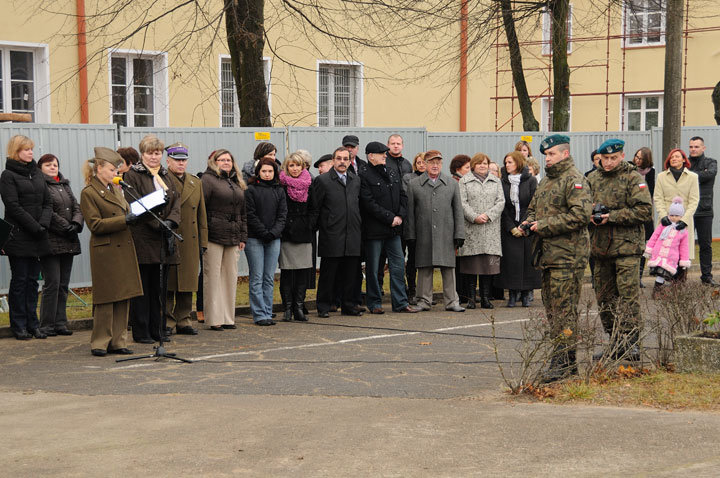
202 149 247 331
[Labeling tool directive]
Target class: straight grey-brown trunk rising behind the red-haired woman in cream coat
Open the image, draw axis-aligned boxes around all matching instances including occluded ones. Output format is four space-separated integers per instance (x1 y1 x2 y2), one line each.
662 0 684 158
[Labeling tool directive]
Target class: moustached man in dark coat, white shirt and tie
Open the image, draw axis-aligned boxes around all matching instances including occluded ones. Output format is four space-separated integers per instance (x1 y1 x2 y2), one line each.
310 147 362 317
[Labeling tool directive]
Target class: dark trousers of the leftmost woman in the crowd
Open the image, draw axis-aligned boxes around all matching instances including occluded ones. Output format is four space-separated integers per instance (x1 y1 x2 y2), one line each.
8 256 40 334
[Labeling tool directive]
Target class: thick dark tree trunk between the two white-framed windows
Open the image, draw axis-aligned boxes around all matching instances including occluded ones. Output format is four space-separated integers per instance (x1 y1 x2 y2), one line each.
225 0 272 127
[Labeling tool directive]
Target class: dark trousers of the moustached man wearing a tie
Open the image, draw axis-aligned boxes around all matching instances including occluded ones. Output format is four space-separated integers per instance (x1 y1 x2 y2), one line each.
317 256 360 314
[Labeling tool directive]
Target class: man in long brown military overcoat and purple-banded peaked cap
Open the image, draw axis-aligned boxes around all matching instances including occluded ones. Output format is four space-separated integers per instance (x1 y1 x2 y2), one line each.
165 143 208 335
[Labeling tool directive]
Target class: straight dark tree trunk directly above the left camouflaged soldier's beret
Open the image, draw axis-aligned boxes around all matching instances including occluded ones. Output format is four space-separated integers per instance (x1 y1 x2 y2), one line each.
549 0 570 131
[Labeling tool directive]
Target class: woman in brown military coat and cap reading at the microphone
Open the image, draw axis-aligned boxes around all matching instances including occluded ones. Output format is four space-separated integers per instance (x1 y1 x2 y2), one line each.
80 147 143 357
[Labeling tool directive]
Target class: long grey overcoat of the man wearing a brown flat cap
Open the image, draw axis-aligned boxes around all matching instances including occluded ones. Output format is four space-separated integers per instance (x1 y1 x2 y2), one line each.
404 173 465 267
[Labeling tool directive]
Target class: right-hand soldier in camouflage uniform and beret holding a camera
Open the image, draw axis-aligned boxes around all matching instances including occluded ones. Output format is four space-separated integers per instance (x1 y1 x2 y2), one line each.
588 139 652 360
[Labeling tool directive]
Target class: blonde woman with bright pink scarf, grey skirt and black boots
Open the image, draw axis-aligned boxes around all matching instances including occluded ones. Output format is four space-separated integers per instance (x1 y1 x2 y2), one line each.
279 151 315 322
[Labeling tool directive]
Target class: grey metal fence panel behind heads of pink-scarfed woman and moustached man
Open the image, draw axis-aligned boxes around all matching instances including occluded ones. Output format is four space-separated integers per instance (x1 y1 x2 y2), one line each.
288 127 426 174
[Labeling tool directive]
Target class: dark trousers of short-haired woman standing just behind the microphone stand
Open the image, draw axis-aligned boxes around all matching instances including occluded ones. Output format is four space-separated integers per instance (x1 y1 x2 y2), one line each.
130 264 167 341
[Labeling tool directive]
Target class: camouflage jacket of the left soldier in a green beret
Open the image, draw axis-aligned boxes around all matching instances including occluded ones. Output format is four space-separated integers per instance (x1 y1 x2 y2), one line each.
527 157 592 268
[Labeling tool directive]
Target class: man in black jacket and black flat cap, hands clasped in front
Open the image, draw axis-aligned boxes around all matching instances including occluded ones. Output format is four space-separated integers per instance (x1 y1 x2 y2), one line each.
360 141 419 314
